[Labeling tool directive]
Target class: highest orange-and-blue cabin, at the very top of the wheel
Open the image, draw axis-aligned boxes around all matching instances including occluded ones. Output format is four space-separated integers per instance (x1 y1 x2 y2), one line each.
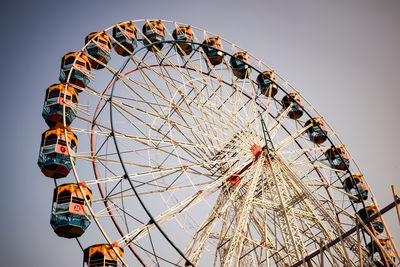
142 20 165 51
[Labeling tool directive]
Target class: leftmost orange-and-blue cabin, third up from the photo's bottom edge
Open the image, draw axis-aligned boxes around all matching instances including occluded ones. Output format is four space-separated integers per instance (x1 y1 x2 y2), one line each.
38 128 78 179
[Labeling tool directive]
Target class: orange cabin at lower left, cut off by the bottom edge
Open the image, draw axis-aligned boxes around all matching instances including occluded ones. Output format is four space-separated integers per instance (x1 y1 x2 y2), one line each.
83 244 124 267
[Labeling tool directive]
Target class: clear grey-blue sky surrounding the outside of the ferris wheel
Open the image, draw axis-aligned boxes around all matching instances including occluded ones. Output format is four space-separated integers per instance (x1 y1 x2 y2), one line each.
0 0 400 267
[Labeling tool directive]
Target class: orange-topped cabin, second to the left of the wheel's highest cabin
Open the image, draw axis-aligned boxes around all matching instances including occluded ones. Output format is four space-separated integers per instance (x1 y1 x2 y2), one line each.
85 32 112 70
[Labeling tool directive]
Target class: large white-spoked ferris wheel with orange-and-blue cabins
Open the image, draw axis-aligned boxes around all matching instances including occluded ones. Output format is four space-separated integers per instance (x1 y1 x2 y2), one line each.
38 19 396 266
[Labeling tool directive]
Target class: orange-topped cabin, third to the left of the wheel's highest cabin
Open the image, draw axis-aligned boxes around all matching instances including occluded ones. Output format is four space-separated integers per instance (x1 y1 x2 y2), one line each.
59 52 91 90
